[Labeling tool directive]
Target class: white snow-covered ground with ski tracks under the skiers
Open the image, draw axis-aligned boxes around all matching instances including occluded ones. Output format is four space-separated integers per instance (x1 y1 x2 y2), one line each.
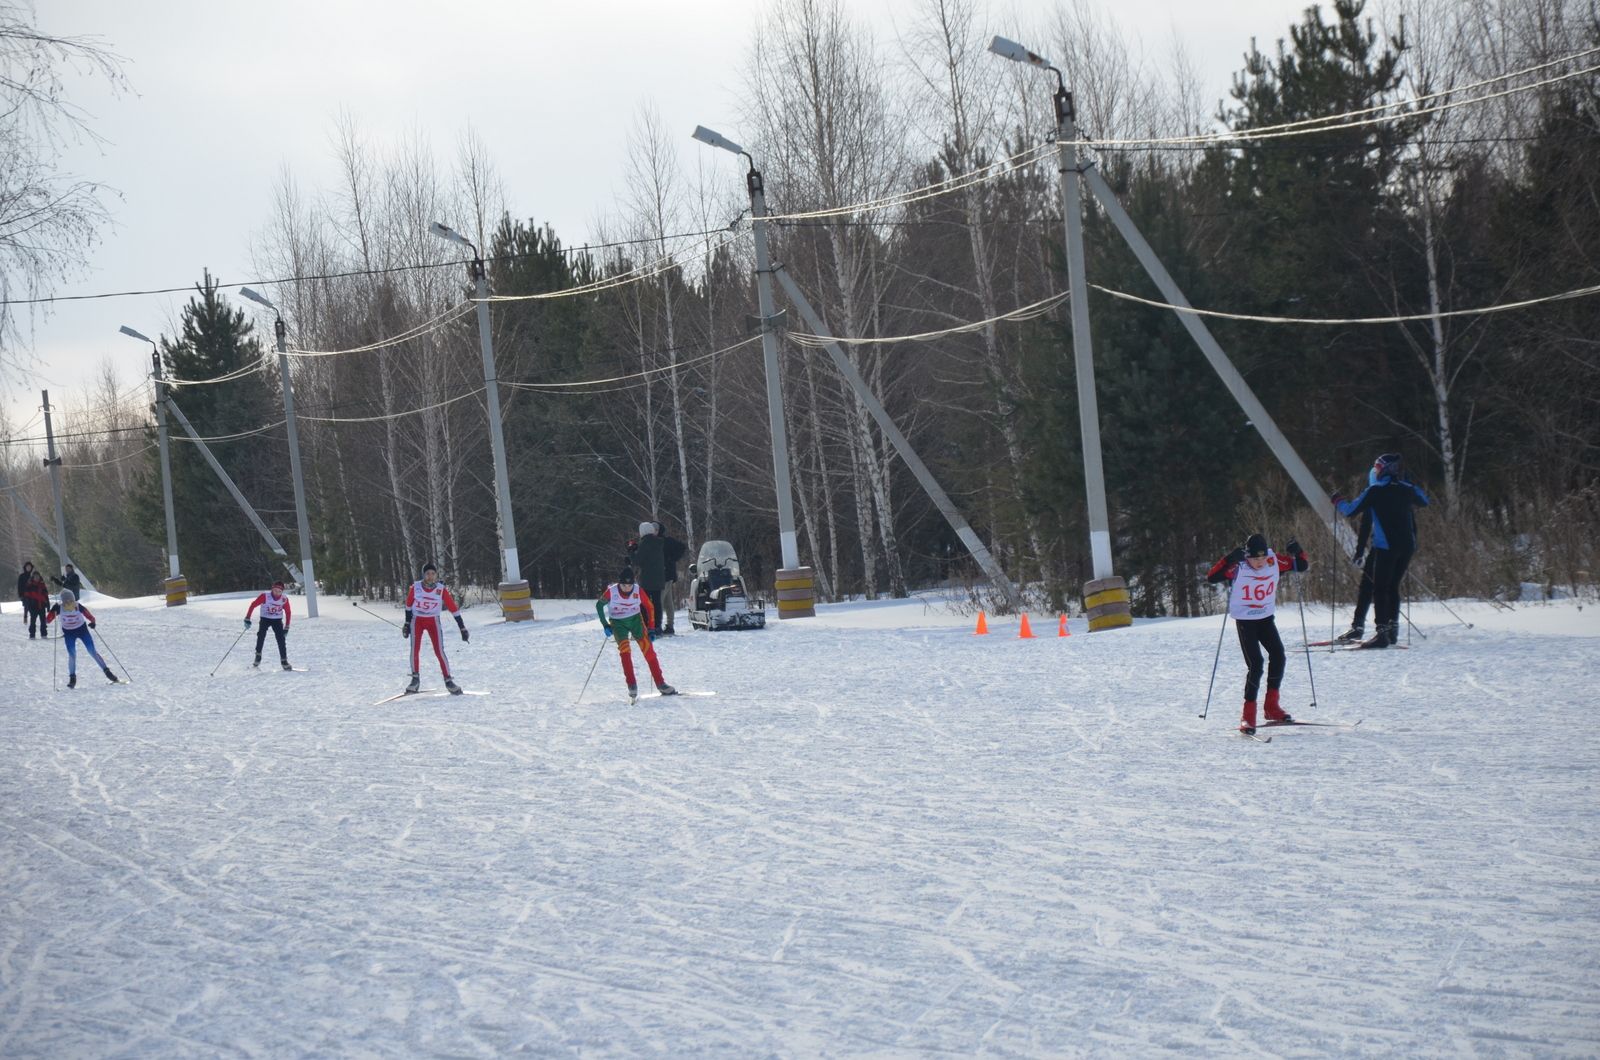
0 594 1600 1058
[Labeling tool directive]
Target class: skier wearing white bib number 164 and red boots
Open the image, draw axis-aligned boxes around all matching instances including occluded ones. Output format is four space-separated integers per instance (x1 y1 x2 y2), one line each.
1206 533 1309 735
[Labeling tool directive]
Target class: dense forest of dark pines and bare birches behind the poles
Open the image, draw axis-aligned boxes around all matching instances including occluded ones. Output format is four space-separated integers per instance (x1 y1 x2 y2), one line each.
0 0 1600 615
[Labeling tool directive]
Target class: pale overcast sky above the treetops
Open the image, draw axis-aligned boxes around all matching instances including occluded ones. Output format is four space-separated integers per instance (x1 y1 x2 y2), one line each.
5 0 1309 434
